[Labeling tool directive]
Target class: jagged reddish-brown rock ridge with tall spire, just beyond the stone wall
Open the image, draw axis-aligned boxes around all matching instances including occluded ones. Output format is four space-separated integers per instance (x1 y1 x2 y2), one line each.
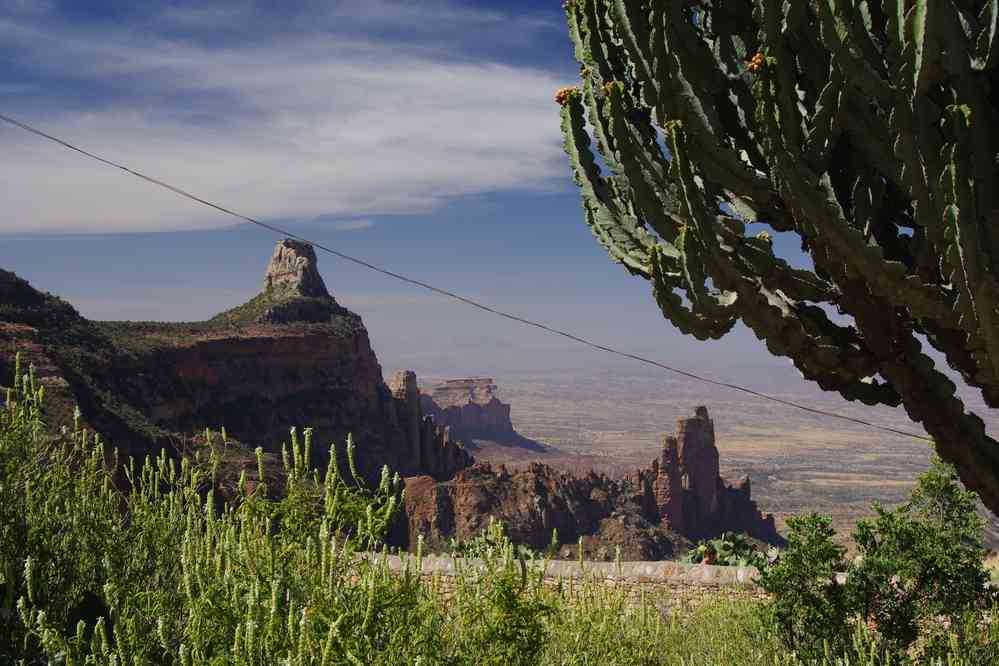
406 407 781 559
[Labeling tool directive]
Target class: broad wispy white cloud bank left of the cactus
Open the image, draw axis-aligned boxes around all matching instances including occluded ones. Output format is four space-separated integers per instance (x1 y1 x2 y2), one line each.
0 2 571 233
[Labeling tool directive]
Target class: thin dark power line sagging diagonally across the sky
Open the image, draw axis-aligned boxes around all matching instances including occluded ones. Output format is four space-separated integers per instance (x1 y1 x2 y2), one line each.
0 114 933 442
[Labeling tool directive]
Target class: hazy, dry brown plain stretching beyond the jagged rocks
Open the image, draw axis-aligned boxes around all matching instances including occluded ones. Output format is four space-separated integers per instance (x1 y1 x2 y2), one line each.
421 368 999 547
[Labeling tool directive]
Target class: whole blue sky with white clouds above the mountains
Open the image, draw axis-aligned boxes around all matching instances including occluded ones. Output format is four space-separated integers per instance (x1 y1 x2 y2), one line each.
0 0 808 379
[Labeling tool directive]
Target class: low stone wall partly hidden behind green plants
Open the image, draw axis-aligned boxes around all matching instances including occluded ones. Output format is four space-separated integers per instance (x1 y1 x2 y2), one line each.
364 553 766 607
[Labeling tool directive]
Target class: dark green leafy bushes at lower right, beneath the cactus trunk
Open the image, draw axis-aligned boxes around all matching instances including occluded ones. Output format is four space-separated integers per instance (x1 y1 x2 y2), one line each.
758 460 999 663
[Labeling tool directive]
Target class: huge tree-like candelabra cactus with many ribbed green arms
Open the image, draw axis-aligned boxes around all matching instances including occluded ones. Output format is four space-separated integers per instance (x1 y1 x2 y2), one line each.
556 0 999 512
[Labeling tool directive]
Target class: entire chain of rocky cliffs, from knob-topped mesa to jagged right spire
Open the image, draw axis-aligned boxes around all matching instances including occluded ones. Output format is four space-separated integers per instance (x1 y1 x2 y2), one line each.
0 240 780 559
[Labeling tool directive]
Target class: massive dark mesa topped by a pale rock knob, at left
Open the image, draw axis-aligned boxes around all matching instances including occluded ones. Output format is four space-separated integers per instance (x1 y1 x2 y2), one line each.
0 240 472 480
